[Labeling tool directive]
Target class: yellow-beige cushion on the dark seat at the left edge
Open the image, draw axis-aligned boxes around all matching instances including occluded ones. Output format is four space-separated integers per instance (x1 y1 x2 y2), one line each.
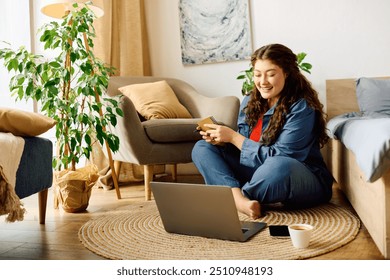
0 108 56 136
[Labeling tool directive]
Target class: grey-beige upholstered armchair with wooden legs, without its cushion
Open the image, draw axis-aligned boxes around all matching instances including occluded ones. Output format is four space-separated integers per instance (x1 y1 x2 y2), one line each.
108 76 240 200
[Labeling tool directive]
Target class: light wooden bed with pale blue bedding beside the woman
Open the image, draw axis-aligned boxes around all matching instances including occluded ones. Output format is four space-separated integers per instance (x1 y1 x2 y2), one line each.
325 77 390 259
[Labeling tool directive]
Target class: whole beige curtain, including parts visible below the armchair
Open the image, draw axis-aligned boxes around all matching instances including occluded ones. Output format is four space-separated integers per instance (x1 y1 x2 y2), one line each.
91 0 151 189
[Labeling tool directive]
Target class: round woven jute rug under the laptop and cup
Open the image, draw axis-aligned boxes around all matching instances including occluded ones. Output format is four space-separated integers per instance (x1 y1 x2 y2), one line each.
79 201 360 260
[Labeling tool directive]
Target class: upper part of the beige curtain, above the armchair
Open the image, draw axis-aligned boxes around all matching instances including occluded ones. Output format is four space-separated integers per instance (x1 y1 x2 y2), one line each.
93 0 151 76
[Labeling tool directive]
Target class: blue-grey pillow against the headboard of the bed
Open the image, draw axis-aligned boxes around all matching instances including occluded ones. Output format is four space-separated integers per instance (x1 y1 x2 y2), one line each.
356 78 390 116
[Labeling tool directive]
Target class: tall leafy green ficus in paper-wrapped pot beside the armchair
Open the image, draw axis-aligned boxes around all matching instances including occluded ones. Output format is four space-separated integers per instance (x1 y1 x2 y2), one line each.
0 3 123 212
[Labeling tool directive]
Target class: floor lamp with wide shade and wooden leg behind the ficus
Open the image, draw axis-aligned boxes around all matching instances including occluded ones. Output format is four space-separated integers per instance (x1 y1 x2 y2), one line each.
41 0 121 199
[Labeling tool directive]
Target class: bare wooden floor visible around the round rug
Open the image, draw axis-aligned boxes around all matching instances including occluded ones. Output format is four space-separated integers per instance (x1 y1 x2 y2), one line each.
0 175 383 260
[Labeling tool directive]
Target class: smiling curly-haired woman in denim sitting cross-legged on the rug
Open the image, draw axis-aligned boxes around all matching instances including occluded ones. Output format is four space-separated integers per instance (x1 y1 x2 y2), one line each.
192 44 333 219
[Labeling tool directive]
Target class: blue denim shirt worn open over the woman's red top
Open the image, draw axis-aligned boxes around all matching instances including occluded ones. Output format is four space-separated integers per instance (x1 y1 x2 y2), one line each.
237 96 333 184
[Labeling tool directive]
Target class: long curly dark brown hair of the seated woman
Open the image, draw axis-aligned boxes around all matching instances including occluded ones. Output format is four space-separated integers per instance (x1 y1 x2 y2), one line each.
244 44 329 147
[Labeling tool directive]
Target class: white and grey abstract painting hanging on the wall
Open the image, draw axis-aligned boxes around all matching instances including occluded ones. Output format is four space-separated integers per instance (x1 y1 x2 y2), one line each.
179 0 252 65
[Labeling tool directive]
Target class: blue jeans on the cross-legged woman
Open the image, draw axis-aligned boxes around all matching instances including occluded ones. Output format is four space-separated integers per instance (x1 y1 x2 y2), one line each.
192 140 331 207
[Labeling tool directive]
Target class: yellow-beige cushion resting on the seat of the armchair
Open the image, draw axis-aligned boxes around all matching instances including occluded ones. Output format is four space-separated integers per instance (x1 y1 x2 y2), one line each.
119 80 192 120
